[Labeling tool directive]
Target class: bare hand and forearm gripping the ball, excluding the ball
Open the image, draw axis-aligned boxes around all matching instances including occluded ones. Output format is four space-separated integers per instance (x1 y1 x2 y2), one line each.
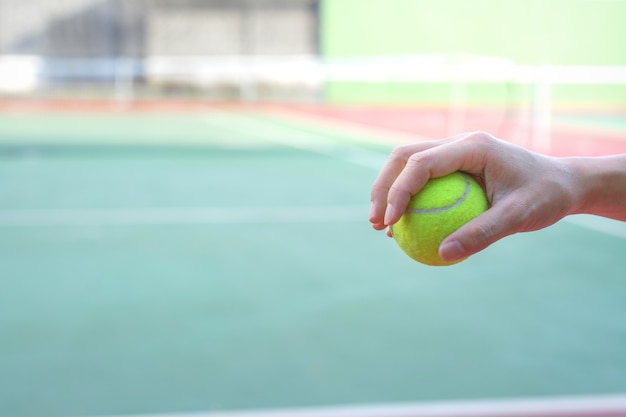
369 132 626 261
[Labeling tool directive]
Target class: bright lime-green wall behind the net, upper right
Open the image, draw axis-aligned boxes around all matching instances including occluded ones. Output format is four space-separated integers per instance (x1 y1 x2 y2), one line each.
320 0 626 104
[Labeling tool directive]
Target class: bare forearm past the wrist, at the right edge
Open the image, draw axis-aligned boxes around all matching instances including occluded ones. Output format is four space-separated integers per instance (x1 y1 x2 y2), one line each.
564 154 626 221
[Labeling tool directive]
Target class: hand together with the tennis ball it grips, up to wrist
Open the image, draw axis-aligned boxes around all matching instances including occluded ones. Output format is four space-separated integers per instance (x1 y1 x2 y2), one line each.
369 132 581 265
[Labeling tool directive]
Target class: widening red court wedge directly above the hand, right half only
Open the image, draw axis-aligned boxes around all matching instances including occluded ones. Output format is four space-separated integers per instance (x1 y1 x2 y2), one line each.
280 106 626 156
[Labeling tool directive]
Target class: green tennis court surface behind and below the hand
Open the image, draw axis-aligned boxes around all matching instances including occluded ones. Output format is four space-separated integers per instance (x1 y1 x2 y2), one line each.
0 111 626 417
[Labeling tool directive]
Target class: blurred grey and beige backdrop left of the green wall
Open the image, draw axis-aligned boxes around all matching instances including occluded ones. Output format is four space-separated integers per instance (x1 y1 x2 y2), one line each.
2 0 319 100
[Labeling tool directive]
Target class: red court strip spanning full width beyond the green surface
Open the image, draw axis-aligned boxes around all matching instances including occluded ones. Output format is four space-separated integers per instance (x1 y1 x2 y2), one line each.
0 100 626 156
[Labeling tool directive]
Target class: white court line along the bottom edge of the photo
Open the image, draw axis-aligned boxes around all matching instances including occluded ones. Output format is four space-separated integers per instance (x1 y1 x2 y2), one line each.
88 395 626 417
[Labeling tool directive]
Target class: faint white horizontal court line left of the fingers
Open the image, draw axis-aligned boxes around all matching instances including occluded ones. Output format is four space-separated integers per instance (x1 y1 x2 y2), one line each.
0 205 369 227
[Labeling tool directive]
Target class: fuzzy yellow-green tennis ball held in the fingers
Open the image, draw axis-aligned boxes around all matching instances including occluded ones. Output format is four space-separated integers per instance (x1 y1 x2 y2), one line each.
391 172 489 266
